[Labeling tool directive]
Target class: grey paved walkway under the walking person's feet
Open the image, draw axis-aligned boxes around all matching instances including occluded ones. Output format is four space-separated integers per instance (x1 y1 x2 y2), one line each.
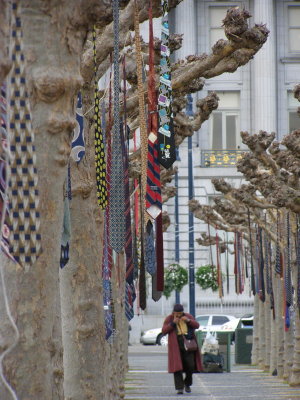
125 345 300 400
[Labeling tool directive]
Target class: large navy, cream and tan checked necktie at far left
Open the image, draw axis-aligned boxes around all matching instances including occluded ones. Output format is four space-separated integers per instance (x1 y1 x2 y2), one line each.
8 2 41 268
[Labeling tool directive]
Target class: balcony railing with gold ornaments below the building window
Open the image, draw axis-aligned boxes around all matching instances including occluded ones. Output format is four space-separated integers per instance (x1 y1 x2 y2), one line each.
201 150 245 168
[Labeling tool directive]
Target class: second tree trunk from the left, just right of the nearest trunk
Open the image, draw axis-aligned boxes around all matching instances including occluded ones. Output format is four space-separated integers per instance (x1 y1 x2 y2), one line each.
60 170 107 400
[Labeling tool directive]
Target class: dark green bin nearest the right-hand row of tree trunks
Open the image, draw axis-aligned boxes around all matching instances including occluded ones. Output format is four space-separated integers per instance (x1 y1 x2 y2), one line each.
235 328 253 364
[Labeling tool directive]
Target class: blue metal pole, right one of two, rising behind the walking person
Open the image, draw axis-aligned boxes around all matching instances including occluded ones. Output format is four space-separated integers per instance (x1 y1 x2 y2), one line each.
186 94 196 316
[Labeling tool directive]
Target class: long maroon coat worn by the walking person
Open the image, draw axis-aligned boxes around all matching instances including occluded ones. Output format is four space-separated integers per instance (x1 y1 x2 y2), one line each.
162 313 202 373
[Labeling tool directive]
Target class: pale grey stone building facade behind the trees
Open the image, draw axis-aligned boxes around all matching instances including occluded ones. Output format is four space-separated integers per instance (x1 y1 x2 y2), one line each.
131 0 300 340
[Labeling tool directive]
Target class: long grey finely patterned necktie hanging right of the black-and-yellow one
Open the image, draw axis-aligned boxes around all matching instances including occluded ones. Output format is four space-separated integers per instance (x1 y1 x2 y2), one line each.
109 0 126 253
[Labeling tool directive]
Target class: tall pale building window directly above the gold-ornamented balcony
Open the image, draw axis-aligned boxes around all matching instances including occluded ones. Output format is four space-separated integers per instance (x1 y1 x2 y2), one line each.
210 92 241 150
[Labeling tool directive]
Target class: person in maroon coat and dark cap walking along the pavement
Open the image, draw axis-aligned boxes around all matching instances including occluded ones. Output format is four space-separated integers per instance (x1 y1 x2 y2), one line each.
162 304 202 394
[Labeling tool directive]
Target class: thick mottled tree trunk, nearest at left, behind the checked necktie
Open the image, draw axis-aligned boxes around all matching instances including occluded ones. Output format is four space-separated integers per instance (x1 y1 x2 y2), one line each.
4 0 89 400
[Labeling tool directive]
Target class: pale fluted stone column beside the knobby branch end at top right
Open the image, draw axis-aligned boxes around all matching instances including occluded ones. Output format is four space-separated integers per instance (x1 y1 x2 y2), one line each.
251 0 277 133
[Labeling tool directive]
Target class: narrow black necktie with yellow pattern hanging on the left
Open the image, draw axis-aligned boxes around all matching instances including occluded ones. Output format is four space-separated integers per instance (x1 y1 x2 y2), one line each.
93 26 107 209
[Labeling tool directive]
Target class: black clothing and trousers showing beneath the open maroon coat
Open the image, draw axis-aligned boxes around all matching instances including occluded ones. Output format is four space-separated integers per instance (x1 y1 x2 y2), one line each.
174 335 195 390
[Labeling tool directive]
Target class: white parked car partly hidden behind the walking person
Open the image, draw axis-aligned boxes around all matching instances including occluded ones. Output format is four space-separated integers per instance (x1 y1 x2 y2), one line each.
140 314 239 346
